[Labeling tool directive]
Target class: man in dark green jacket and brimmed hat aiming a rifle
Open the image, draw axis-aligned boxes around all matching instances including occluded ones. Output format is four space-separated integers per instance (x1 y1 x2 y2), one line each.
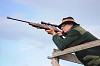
46 17 100 66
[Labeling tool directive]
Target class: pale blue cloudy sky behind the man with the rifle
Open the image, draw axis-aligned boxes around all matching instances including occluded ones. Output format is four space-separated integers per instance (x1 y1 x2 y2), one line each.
0 0 100 66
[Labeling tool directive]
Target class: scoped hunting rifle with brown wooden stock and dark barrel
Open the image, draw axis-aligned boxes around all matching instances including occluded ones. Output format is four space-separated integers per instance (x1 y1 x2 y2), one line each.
7 17 60 32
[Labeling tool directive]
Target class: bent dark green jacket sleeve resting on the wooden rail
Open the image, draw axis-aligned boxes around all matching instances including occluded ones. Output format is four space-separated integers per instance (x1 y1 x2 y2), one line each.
52 30 81 50
